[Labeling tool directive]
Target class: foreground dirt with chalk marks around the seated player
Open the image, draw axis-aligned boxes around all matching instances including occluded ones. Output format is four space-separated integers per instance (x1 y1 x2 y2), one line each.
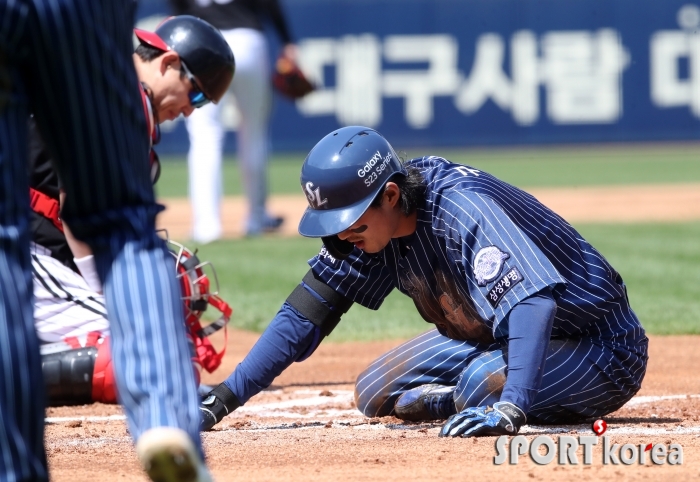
46 331 700 482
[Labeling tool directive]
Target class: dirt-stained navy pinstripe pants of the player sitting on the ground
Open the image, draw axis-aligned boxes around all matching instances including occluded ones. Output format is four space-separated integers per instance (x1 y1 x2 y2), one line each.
355 309 647 423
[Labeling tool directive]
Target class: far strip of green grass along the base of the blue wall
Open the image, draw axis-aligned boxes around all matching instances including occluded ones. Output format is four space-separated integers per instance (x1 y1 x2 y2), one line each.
156 144 700 197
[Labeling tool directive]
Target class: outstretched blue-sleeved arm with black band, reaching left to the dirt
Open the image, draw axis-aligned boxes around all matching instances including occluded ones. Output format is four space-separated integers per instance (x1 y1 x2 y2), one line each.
200 271 352 430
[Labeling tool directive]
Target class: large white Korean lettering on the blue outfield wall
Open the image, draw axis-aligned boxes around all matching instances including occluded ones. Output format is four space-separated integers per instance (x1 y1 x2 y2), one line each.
297 29 628 129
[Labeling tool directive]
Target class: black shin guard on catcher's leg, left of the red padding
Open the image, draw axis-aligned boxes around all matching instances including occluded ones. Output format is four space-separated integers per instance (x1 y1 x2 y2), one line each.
41 346 97 407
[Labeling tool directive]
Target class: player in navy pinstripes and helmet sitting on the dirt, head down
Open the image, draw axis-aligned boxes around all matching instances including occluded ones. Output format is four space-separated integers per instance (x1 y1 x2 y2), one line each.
201 126 648 437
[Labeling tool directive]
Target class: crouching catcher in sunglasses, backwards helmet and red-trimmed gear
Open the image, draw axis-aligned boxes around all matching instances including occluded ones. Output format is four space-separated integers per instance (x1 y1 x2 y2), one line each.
29 16 234 406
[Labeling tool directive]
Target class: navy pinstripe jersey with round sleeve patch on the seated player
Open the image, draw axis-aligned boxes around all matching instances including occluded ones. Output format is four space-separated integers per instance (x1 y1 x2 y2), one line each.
309 157 643 343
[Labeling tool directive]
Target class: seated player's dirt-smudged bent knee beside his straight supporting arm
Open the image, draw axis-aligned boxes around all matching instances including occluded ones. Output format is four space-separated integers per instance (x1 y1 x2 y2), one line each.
455 350 506 412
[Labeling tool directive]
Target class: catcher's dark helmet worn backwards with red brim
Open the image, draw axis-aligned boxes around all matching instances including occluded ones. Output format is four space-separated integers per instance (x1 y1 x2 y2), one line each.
134 15 236 104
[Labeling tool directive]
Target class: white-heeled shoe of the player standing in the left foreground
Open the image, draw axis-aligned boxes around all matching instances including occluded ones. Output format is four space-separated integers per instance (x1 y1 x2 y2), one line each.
136 427 213 482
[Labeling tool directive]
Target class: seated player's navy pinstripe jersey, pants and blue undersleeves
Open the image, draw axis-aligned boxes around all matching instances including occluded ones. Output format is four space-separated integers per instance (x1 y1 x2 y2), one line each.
224 157 648 422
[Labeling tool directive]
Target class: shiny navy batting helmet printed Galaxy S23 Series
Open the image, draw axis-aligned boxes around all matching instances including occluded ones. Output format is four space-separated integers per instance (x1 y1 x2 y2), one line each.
299 126 406 243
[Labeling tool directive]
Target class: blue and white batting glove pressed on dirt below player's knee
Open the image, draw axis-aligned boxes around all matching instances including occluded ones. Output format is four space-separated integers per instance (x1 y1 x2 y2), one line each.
440 402 527 437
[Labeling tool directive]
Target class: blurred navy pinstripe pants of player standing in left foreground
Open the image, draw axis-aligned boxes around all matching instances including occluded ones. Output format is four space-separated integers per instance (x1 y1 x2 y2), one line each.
0 0 201 481
